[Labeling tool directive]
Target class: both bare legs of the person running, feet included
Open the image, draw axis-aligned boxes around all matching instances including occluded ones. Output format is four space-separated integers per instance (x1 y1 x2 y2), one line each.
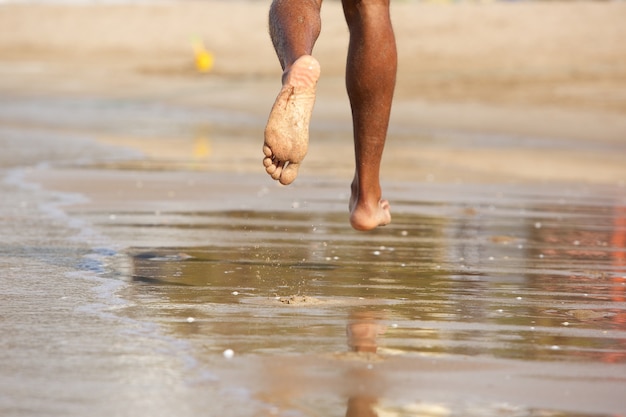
263 0 397 230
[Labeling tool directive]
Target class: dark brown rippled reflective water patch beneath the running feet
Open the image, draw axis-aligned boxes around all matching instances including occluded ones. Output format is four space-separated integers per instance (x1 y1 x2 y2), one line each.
119 202 626 363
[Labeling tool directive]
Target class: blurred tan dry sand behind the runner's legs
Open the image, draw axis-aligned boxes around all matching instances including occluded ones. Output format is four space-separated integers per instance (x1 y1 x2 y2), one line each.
0 0 626 184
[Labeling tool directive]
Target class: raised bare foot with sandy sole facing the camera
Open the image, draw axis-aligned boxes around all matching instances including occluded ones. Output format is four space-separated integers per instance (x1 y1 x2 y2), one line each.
263 55 320 185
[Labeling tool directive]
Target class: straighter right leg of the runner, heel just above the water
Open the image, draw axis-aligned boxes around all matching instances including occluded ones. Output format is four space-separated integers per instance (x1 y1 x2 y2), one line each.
342 0 397 230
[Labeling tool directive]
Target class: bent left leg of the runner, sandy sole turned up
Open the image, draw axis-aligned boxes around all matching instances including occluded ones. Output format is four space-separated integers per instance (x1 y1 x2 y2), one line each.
263 0 322 184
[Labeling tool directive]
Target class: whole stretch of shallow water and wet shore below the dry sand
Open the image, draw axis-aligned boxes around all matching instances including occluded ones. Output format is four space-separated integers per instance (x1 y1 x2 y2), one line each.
0 96 626 417
